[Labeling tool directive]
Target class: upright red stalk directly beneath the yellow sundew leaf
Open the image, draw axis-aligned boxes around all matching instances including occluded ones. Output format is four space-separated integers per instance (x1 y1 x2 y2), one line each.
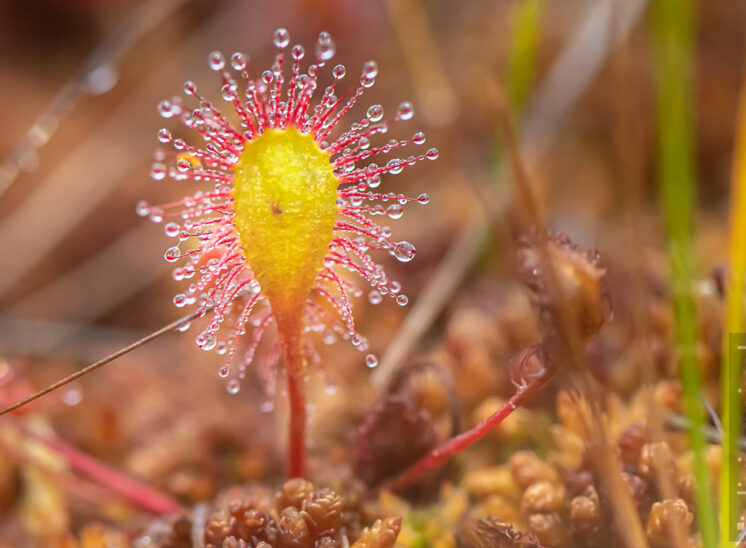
285 337 306 478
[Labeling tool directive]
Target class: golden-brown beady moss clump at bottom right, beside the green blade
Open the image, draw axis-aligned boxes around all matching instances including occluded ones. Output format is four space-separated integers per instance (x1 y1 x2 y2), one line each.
457 380 708 548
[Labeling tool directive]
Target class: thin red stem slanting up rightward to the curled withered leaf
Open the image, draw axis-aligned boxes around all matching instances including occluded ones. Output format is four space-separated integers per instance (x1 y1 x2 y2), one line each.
381 373 552 491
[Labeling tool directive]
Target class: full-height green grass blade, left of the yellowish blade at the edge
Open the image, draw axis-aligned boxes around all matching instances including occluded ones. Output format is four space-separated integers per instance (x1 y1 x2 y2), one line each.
652 0 717 548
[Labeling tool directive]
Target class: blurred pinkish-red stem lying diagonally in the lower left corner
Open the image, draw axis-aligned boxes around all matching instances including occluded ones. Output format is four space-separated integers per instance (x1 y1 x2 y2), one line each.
3 417 183 515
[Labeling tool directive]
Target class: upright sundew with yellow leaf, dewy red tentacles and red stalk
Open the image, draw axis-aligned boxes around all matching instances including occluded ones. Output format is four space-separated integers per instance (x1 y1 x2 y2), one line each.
137 29 438 476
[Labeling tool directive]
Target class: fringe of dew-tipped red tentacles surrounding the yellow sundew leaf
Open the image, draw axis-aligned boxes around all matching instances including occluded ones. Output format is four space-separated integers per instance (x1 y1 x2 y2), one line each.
137 29 438 392
